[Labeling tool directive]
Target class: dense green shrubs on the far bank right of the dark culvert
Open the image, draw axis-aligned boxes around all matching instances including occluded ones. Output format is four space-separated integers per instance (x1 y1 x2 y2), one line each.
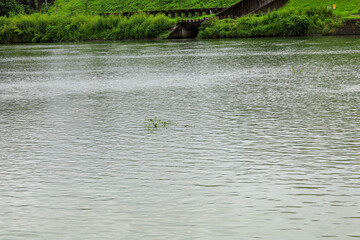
199 8 341 38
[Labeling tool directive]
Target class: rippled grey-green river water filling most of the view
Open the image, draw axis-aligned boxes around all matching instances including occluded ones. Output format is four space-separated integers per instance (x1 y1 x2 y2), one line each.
0 37 360 240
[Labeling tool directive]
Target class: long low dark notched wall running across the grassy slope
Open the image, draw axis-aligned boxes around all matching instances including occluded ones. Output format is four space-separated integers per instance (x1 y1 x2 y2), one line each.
100 8 225 18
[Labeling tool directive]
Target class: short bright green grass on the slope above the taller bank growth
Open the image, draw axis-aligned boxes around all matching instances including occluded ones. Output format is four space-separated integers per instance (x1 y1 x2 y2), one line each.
50 0 360 16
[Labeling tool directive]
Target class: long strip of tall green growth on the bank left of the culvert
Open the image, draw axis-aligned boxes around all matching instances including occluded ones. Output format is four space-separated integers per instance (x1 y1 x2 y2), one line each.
0 14 175 43
